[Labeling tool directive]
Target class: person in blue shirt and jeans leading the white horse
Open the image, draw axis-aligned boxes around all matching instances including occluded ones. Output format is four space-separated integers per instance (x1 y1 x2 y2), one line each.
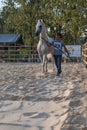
43 33 69 76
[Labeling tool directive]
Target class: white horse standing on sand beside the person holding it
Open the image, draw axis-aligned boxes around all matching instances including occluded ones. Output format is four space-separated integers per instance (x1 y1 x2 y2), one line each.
36 20 54 72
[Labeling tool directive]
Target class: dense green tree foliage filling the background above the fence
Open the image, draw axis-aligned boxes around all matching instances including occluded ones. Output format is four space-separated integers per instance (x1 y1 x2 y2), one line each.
0 0 87 44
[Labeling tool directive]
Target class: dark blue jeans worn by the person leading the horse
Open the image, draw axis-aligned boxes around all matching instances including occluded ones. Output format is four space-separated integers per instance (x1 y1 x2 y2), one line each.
54 55 62 73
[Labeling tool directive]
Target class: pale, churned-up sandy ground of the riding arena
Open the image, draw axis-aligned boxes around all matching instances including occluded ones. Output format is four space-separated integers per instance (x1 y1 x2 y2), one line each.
0 63 87 130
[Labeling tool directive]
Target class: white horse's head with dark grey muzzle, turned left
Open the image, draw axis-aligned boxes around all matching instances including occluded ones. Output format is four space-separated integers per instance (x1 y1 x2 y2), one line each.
35 20 45 36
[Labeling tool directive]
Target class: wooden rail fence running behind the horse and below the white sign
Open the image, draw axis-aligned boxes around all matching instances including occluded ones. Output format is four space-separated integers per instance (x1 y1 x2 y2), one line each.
0 46 81 62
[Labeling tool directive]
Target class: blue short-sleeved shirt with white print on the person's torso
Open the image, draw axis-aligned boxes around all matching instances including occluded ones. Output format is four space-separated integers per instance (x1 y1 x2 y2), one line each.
52 40 64 55
